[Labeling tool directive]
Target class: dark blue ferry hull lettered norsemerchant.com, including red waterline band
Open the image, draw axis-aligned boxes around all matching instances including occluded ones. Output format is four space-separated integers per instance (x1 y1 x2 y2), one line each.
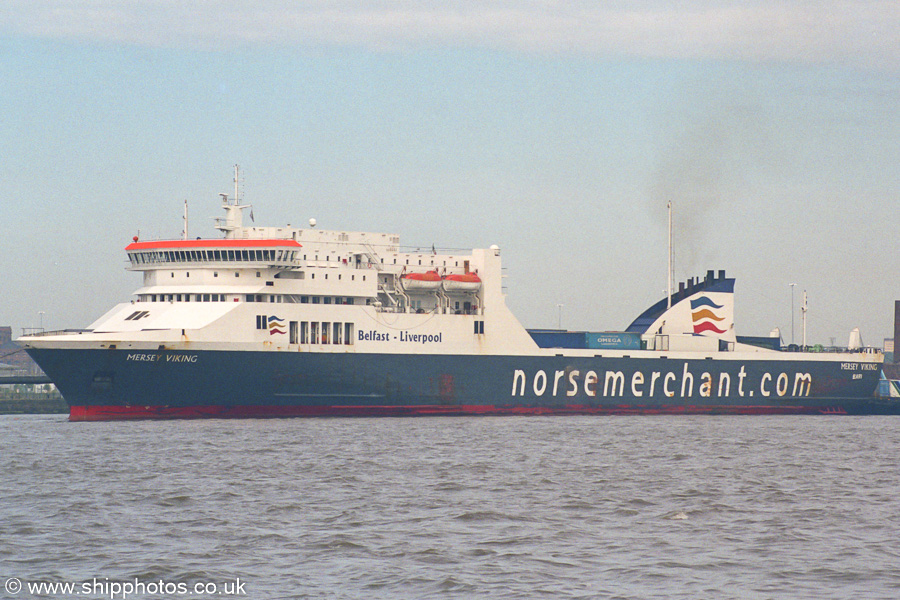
22 348 900 421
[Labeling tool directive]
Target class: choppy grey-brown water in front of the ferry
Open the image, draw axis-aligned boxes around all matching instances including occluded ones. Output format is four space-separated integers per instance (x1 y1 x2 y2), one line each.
0 416 900 599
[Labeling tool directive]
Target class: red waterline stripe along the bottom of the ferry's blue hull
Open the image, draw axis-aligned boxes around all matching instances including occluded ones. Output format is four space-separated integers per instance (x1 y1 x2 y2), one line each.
69 405 847 421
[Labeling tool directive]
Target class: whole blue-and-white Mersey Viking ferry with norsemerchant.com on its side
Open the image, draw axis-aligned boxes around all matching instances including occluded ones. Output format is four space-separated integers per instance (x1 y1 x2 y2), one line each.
19 172 900 421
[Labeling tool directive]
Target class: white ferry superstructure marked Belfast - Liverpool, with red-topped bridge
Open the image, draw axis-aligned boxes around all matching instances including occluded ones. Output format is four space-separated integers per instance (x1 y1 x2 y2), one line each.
75 186 537 354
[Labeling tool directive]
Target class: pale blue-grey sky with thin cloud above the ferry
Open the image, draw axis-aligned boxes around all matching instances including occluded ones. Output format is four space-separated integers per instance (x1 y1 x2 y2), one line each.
0 0 900 345
